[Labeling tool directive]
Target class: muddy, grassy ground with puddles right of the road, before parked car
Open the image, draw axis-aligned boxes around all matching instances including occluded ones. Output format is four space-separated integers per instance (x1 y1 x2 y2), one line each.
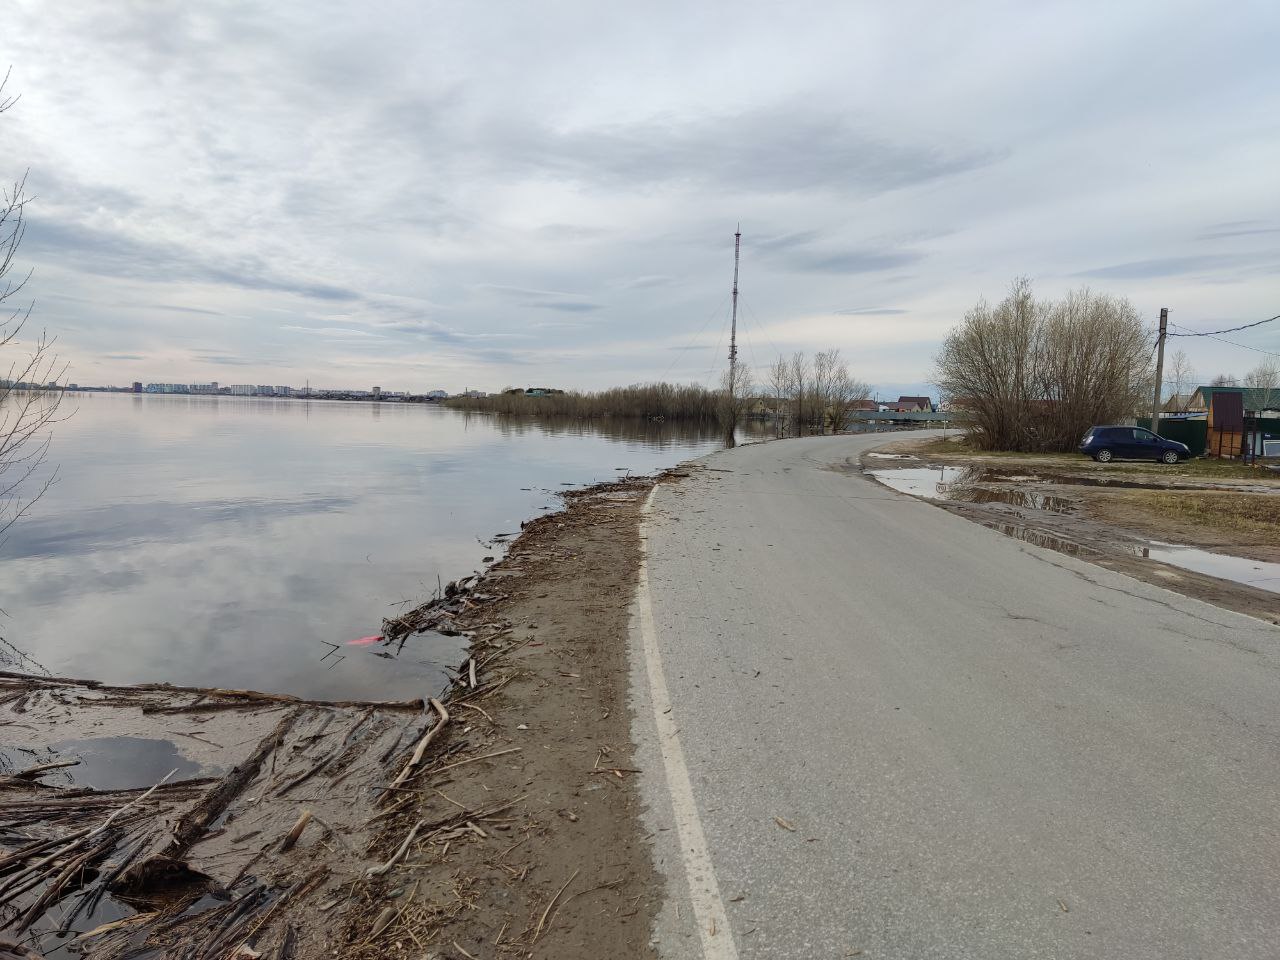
851 438 1280 632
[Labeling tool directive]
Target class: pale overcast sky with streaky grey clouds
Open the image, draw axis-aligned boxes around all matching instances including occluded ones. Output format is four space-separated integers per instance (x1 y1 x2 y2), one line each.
0 0 1280 393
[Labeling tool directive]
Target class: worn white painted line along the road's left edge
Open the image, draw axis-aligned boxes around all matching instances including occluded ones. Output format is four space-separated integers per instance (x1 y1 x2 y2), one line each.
636 486 737 960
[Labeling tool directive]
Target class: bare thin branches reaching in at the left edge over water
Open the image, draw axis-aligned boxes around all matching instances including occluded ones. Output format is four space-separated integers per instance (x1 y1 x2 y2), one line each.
0 73 65 535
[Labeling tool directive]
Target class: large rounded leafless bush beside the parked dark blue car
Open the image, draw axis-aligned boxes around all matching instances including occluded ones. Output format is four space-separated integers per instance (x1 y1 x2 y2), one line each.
936 278 1155 452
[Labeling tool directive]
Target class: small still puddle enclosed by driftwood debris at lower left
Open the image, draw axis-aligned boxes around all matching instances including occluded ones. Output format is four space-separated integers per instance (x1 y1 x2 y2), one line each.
0 737 209 790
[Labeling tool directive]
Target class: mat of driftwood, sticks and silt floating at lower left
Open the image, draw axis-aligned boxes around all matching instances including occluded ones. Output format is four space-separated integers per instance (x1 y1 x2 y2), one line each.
0 660 476 960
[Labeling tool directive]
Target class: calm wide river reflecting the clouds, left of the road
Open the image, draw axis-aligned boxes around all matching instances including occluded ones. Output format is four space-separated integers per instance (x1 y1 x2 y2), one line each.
0 394 747 699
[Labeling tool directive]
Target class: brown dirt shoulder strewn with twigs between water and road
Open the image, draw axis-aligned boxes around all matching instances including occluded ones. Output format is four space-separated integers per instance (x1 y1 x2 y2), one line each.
326 471 681 960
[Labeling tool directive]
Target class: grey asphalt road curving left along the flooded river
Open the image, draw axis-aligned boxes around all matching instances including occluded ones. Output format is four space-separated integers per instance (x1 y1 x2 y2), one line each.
632 436 1280 960
